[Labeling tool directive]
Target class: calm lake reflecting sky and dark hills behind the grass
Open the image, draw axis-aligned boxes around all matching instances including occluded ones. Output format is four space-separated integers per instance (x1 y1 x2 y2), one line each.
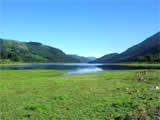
0 63 158 75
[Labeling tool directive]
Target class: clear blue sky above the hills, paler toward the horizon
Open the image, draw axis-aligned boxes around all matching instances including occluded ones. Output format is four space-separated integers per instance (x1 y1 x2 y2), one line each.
0 0 160 56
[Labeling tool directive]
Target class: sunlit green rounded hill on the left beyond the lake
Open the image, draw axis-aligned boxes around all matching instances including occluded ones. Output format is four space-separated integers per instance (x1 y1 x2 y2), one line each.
0 39 80 62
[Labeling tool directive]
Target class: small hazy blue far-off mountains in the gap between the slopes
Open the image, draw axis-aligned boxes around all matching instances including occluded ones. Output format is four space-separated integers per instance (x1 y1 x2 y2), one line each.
69 55 96 63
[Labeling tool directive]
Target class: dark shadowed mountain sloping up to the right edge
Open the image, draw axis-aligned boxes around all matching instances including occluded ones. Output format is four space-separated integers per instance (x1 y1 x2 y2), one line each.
93 32 160 63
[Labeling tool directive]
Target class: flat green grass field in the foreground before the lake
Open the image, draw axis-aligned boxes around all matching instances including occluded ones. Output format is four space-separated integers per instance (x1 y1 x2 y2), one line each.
0 70 160 120
